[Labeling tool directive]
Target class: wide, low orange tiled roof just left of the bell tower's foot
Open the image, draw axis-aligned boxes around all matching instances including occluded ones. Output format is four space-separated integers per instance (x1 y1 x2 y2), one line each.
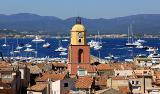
37 73 66 81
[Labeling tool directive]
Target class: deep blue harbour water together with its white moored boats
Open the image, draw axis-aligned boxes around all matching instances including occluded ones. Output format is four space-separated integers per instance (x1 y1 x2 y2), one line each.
0 38 160 62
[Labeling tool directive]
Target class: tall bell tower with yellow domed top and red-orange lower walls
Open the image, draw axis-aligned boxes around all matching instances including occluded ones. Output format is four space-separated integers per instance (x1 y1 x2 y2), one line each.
68 17 90 75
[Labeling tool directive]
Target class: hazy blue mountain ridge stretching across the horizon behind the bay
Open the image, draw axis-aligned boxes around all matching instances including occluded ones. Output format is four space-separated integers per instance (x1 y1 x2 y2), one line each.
0 13 160 34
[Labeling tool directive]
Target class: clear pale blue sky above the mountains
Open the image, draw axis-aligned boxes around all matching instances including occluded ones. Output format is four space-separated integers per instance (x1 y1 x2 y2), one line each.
0 0 160 19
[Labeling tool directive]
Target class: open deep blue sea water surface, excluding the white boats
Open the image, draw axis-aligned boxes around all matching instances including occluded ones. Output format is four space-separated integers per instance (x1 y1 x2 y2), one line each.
0 38 160 60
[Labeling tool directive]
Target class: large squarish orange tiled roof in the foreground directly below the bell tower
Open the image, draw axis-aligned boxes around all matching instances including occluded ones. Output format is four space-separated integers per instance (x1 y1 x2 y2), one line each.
75 76 93 89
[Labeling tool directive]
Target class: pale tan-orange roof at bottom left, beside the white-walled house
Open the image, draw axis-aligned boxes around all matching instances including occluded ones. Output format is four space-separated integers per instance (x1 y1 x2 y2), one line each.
27 83 47 91
